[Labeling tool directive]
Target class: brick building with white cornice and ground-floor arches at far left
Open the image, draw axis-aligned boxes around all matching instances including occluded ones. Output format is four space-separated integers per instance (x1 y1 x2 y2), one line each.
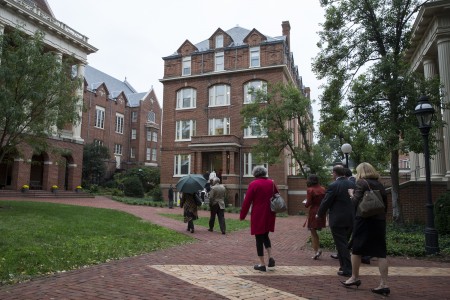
0 0 97 190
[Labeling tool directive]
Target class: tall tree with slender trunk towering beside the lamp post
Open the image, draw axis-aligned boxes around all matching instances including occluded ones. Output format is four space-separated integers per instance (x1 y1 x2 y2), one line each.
313 0 441 223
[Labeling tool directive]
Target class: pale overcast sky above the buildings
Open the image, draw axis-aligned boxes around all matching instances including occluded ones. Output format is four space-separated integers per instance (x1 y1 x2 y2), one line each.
47 0 323 122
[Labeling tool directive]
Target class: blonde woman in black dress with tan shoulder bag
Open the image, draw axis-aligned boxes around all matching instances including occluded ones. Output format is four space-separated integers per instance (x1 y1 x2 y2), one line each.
342 162 391 296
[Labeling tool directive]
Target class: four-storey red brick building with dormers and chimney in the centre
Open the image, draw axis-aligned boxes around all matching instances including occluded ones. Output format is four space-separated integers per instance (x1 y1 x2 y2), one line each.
161 21 312 206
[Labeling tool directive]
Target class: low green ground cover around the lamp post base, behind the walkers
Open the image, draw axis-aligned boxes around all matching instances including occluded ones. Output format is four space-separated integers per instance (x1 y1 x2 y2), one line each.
319 224 450 261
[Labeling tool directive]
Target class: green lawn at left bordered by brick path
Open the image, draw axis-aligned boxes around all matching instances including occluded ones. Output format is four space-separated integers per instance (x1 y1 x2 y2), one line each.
0 201 193 285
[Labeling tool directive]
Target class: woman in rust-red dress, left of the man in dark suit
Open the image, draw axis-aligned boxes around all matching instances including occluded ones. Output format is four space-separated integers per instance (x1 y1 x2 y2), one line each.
305 174 326 259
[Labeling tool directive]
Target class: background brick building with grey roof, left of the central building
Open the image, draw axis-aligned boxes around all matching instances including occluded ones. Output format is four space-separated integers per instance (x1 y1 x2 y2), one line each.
81 66 162 178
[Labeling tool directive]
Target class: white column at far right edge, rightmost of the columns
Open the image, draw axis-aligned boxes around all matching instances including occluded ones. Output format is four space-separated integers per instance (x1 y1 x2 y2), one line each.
437 36 450 180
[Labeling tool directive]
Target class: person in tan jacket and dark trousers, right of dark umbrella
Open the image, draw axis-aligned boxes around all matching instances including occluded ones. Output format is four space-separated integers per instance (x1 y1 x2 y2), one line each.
208 177 226 234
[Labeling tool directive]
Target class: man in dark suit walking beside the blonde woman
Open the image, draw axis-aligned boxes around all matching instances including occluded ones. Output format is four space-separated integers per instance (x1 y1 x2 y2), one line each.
316 166 355 277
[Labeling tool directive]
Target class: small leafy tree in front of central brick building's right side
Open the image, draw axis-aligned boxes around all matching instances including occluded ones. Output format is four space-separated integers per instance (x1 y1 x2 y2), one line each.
241 83 325 178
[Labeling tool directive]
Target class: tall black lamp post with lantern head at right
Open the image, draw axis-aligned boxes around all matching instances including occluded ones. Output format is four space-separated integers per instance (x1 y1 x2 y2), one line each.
414 95 439 254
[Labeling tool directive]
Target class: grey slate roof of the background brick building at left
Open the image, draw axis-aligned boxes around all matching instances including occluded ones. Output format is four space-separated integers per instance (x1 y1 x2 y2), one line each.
84 65 137 97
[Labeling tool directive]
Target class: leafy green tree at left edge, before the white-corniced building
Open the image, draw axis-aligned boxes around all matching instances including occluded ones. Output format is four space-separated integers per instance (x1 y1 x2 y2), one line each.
0 29 82 162
